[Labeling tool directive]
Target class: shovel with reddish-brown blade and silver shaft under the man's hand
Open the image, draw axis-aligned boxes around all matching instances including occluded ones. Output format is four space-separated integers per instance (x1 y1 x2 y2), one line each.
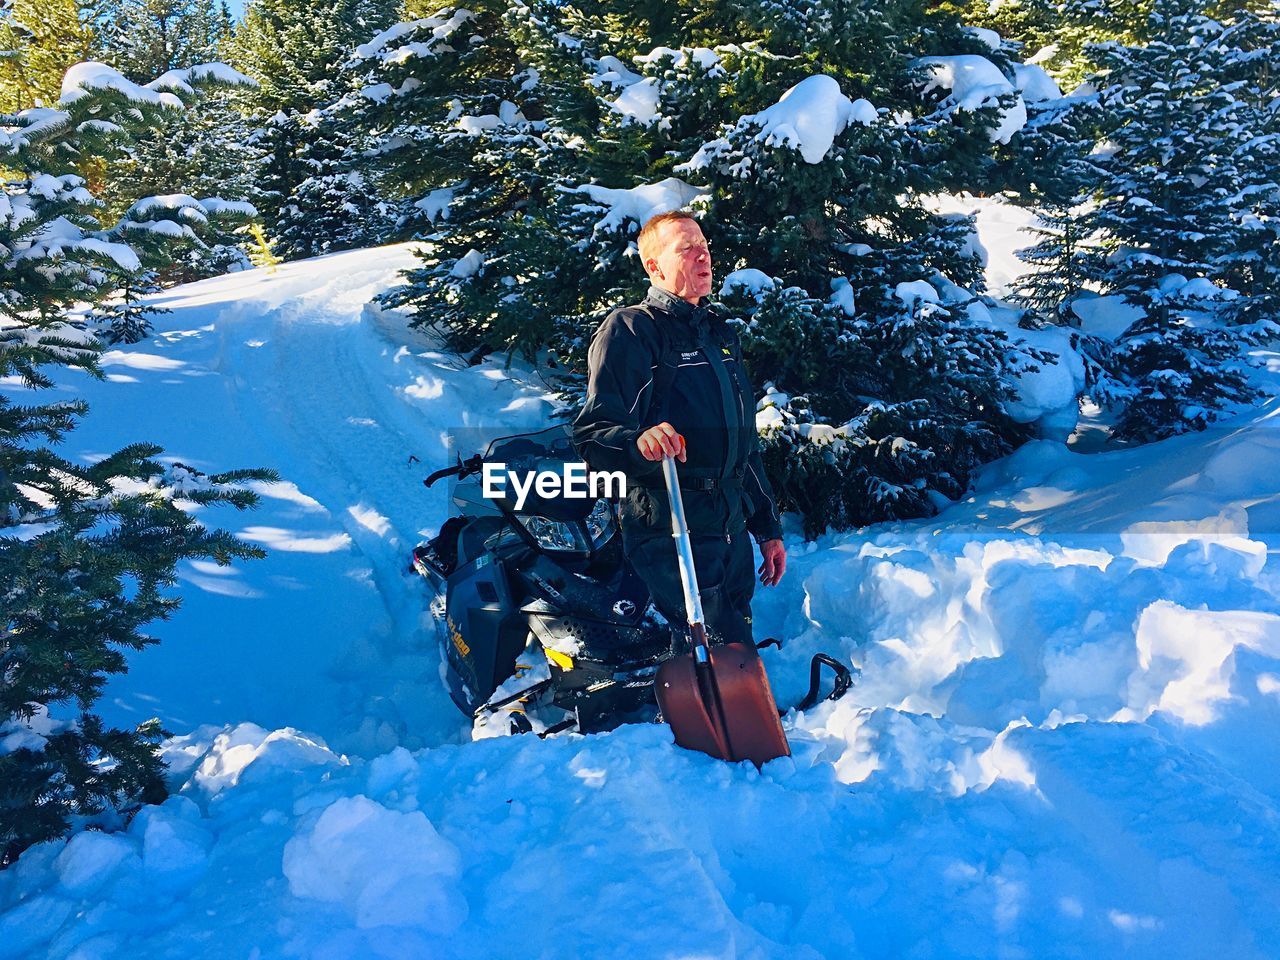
654 456 791 768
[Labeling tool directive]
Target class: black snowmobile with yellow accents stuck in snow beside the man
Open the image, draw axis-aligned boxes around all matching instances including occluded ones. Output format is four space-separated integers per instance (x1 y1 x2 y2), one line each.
412 426 851 739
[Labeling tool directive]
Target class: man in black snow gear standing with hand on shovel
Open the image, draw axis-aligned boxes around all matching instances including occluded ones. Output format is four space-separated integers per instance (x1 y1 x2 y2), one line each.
573 211 787 652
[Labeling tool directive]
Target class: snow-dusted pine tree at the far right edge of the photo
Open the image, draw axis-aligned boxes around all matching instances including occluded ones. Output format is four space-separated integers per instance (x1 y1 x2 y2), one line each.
1084 0 1280 440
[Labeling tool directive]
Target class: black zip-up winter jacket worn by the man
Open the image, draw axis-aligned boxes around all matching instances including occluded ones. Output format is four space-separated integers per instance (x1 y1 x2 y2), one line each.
573 287 782 540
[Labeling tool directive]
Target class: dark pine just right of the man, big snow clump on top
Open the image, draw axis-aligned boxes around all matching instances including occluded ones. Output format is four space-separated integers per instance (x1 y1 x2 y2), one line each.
677 58 1020 535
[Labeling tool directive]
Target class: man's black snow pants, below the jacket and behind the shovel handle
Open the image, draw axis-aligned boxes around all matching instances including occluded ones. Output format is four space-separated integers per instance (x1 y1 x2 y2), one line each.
625 530 755 654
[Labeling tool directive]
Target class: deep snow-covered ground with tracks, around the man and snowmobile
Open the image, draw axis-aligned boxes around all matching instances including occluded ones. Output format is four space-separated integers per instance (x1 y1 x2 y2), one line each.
0 247 1280 960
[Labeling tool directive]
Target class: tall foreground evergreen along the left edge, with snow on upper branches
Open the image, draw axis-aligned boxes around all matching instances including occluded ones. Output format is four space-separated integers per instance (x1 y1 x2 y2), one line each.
0 64 274 867
